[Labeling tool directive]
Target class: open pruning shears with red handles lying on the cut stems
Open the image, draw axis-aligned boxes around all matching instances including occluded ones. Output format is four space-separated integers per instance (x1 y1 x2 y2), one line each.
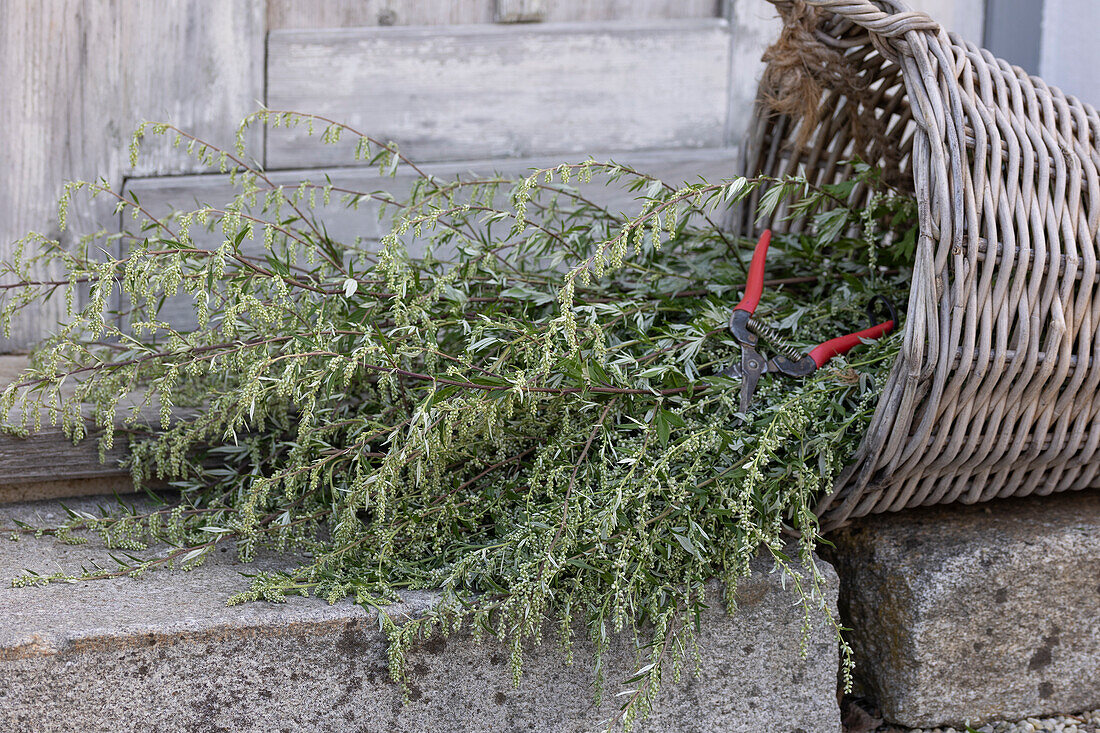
722 229 898 413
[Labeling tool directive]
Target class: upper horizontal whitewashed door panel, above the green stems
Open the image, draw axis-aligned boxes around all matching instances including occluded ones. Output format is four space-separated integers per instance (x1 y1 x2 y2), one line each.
267 19 729 168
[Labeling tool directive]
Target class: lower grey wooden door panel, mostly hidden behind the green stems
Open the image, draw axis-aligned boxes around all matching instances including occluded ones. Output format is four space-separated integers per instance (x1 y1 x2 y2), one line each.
127 147 737 327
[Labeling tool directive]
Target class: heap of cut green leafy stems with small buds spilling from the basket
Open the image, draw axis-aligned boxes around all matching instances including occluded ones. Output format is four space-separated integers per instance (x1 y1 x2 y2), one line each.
3 111 912 726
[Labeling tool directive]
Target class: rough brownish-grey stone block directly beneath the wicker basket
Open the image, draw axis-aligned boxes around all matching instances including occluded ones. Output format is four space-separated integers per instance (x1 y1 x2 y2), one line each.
834 484 1100 727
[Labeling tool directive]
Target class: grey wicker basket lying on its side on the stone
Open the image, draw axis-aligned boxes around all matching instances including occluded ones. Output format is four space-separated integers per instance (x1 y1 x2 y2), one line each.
739 0 1100 528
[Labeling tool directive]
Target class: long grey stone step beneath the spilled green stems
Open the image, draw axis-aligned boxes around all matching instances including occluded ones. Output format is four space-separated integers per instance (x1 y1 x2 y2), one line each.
0 502 839 733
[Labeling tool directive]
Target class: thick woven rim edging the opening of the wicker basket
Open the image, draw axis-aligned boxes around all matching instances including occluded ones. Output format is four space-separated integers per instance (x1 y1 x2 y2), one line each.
756 0 985 523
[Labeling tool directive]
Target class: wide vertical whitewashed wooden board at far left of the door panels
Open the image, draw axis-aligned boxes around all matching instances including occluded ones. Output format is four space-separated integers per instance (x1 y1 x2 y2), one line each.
0 0 264 351
